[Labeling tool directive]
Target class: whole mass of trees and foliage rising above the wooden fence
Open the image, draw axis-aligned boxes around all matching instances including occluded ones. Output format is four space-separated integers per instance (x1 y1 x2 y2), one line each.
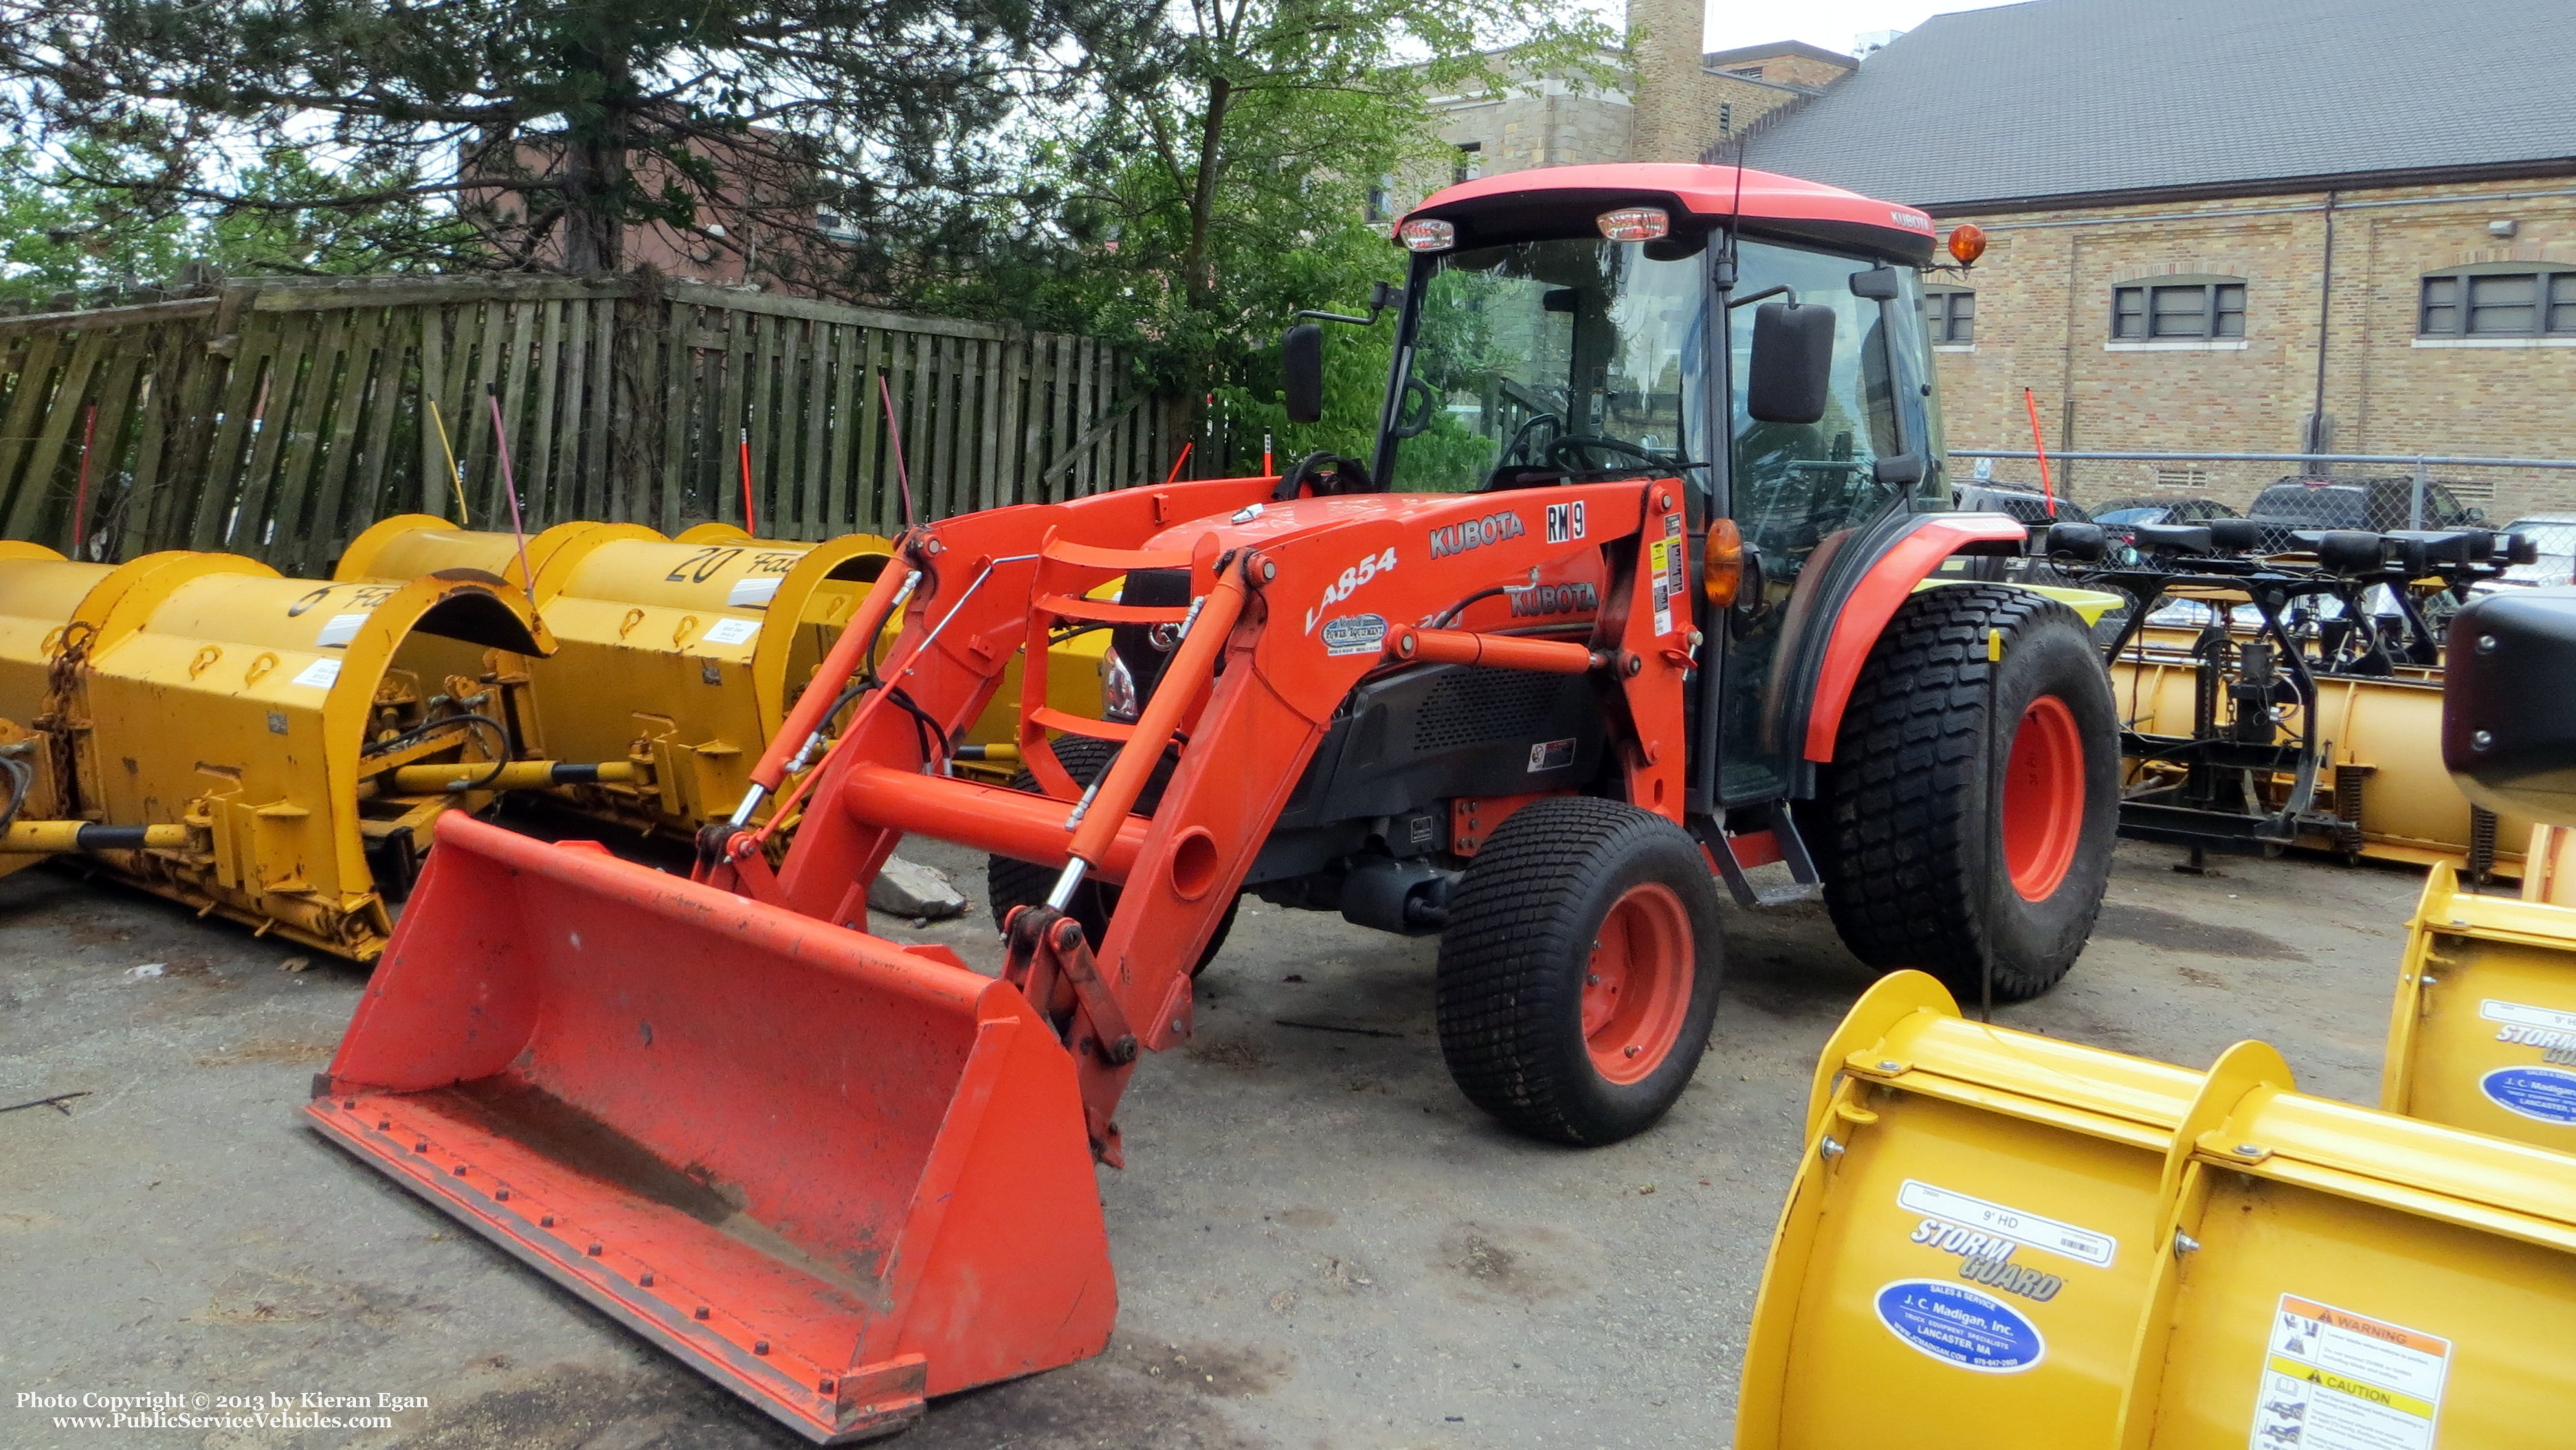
0 0 1620 497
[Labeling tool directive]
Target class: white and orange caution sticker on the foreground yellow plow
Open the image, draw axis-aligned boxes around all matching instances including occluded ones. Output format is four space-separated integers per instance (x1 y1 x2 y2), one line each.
2246 1293 2450 1450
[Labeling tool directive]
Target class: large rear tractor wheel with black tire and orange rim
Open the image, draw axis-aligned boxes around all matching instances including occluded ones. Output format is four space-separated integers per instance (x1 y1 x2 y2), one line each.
1811 585 2120 1002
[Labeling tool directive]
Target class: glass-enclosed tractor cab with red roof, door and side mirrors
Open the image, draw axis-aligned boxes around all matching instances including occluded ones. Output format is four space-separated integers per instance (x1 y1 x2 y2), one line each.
1285 165 1968 812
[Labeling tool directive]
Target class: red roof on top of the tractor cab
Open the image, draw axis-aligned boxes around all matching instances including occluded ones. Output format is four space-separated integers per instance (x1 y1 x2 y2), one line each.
1399 162 1932 265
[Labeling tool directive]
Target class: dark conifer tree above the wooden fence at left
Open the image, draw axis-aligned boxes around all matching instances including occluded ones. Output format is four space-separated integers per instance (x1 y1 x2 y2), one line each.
0 0 1115 291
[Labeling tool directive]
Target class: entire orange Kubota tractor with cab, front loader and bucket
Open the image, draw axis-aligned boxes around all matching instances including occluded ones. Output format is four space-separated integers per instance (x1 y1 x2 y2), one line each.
312 165 2118 1442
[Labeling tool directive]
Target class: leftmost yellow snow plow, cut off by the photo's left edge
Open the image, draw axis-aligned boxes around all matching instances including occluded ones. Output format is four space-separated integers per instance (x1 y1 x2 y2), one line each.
0 544 608 961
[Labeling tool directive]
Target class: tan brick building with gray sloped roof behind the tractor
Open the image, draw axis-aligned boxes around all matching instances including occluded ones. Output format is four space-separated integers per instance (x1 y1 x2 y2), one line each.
1628 0 2576 520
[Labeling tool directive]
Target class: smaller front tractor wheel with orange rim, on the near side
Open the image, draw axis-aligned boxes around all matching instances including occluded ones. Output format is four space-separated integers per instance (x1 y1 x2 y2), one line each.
1435 796 1726 1146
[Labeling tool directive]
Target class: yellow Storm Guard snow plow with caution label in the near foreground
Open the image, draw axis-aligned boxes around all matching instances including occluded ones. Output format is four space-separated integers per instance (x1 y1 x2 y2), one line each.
1733 971 2576 1450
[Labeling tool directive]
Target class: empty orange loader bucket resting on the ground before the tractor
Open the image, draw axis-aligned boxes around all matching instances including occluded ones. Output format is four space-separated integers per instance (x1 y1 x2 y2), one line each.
307 814 1118 1445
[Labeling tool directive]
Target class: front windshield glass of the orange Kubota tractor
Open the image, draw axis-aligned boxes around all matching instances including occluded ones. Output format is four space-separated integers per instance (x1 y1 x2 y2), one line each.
1388 237 1708 492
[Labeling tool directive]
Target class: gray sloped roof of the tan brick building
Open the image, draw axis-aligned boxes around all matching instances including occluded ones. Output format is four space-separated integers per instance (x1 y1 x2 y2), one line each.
1729 0 2576 211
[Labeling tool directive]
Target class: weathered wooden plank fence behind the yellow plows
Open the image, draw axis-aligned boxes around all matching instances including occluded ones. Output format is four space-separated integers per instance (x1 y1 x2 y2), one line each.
0 278 1180 575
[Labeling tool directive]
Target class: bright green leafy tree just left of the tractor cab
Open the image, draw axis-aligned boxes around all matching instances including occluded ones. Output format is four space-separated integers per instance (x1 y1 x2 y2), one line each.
935 0 1620 466
